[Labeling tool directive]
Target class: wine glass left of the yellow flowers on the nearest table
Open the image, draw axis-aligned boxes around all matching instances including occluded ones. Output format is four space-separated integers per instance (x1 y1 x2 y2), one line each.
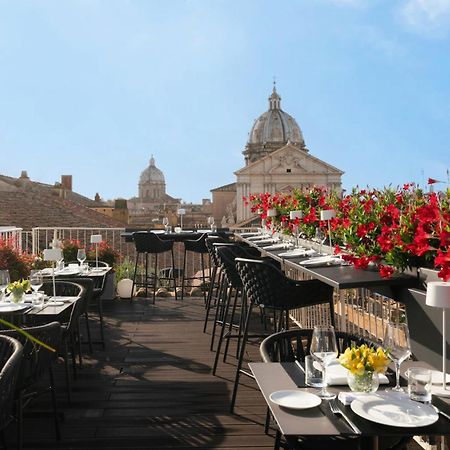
310 325 338 400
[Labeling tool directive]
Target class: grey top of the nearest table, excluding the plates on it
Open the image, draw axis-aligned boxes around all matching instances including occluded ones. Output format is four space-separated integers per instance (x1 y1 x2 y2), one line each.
249 363 450 450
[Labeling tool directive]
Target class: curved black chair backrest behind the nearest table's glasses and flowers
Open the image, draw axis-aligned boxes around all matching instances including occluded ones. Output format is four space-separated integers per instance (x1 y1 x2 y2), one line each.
259 328 379 362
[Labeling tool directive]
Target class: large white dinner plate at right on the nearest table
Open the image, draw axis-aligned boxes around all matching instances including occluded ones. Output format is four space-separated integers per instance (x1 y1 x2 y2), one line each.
350 393 439 428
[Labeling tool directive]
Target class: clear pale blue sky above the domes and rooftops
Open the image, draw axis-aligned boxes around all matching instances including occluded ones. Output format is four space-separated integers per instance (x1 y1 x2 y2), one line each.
0 0 450 202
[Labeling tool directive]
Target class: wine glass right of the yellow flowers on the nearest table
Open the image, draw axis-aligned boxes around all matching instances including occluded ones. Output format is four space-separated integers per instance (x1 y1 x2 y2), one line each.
384 322 411 392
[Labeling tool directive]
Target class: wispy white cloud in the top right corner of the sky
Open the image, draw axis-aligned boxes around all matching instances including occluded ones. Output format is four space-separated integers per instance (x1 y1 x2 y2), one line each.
399 0 450 37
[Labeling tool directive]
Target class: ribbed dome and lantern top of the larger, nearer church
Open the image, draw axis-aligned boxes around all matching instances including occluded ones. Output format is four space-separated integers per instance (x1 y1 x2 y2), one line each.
247 86 305 147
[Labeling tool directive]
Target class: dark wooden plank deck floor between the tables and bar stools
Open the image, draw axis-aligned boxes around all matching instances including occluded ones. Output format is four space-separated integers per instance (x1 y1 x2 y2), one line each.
10 298 273 450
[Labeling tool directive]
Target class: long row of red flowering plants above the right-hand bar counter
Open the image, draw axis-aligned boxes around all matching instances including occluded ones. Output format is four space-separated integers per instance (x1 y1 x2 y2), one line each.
244 183 450 281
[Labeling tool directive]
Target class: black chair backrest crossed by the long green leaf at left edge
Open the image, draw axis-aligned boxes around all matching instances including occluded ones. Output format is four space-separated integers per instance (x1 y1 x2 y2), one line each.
1 322 61 391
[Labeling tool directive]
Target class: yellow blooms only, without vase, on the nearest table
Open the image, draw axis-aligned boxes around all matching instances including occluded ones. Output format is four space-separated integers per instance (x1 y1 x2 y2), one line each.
339 344 389 375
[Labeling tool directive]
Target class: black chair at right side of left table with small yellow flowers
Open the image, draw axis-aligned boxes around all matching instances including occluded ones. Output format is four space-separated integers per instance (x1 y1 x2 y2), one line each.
42 281 87 402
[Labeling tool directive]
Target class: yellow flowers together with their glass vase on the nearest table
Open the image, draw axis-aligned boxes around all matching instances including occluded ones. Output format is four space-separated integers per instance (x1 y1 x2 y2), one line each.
339 344 389 392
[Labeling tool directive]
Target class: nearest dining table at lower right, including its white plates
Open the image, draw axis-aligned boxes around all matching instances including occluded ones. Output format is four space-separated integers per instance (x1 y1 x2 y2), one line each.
249 362 450 450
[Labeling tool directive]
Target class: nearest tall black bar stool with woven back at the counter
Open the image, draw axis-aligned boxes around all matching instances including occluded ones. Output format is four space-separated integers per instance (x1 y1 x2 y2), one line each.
231 258 334 412
